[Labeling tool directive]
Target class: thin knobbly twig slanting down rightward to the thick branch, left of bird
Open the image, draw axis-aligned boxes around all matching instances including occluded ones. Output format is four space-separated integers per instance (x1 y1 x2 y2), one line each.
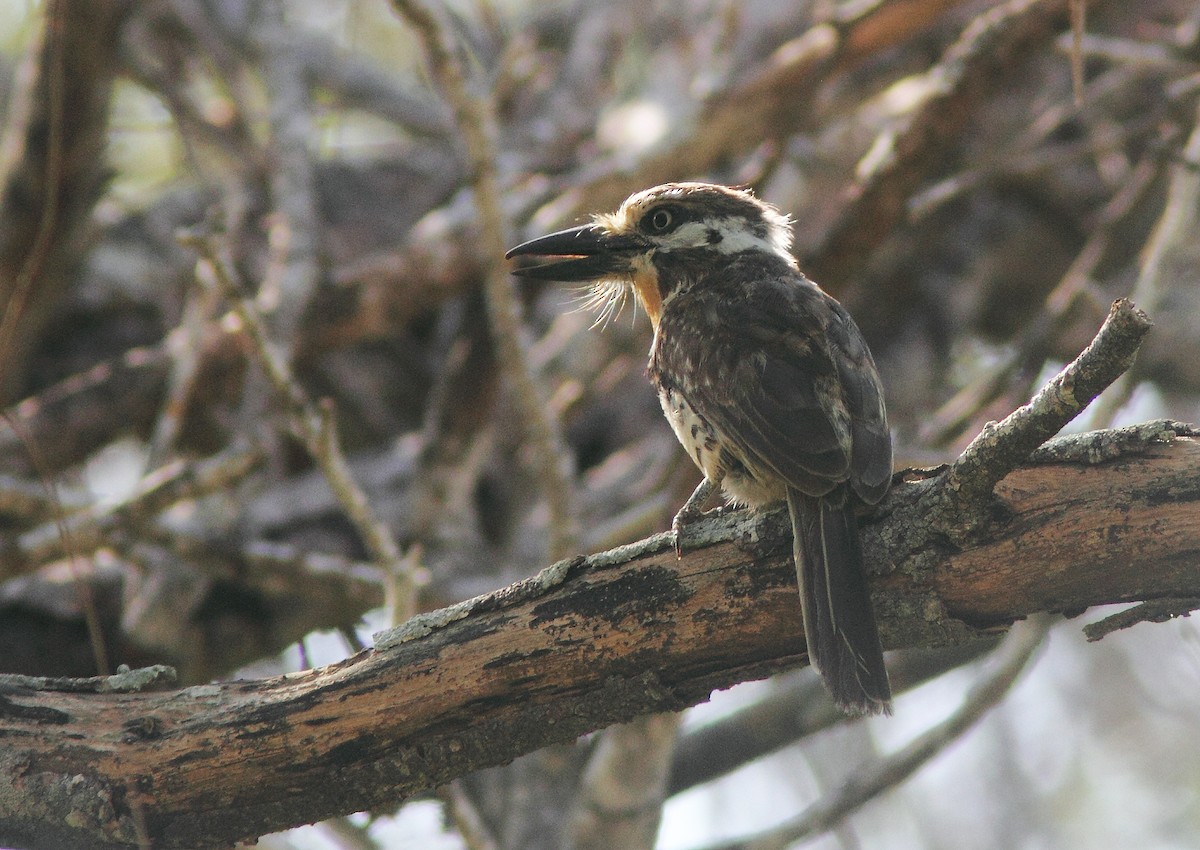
181 235 418 619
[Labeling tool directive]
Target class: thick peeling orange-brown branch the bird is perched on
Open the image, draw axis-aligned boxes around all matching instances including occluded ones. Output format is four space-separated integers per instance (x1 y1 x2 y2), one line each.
0 423 1200 849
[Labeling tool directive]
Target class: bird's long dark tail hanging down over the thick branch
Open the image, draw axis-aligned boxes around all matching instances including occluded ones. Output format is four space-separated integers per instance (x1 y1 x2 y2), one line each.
787 487 892 714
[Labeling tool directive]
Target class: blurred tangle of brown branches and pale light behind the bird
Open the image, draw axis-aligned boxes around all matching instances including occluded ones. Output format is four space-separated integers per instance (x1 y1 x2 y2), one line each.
0 0 1200 850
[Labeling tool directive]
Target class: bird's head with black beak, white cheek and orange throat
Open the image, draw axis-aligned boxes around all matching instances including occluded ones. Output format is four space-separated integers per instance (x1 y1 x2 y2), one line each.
505 182 796 327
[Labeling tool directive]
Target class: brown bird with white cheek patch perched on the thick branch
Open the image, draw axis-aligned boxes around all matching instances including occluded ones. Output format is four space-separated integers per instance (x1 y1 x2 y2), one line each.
505 182 892 714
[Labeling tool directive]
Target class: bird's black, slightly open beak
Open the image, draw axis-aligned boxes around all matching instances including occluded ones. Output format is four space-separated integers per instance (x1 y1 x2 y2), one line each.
504 225 641 281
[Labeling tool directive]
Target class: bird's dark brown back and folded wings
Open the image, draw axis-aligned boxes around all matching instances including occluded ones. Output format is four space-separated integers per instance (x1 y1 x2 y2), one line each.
660 268 892 502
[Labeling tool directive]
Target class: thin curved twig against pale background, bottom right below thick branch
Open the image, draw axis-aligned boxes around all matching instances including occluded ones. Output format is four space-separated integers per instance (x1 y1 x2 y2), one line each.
708 615 1051 850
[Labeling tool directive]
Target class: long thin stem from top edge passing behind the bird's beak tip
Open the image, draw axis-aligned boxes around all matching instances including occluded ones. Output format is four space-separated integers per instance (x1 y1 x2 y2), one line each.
392 0 577 558
